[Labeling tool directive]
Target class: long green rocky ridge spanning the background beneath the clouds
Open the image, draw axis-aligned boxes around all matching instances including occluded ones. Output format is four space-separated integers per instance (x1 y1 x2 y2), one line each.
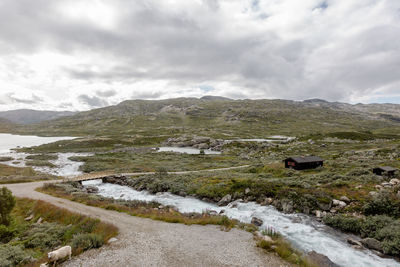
14 97 400 138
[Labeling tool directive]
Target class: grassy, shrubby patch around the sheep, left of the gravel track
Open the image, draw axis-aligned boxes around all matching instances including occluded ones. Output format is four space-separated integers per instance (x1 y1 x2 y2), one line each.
0 187 118 267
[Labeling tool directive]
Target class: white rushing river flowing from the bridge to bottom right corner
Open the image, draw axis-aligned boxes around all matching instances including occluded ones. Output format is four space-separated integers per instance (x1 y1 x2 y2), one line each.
83 180 400 267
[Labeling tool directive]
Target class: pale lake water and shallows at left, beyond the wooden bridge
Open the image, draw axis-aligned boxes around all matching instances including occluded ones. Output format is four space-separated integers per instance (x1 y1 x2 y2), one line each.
0 134 91 176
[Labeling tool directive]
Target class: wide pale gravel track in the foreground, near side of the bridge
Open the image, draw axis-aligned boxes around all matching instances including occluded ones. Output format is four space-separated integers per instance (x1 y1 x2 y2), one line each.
6 182 288 267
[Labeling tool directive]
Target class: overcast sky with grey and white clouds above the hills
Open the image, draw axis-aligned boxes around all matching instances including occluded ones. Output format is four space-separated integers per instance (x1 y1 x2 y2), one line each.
0 0 400 110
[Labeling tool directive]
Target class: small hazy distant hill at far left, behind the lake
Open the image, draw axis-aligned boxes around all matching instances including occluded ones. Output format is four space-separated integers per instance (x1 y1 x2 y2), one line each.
0 109 76 124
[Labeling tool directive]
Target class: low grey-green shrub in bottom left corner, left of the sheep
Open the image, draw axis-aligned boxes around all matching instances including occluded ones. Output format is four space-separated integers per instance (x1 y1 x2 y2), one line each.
0 245 32 267
